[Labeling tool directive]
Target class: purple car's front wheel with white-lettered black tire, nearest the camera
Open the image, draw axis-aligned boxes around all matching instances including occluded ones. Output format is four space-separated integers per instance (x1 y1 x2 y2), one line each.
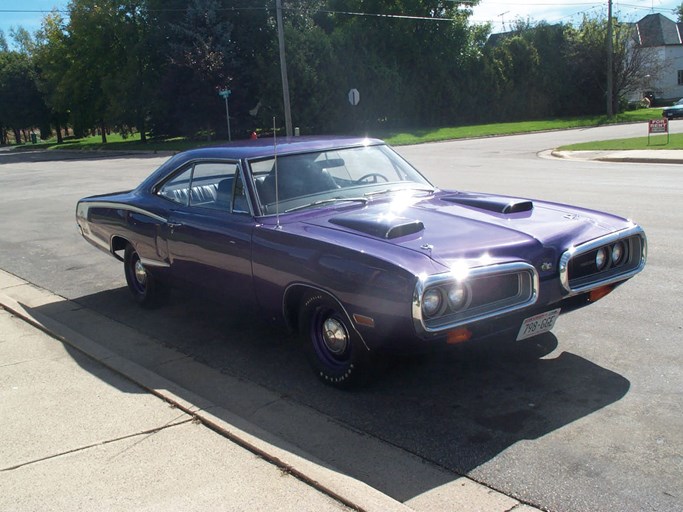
299 292 374 389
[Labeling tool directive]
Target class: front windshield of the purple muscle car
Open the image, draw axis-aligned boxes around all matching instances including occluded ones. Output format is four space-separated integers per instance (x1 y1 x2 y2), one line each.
250 145 434 215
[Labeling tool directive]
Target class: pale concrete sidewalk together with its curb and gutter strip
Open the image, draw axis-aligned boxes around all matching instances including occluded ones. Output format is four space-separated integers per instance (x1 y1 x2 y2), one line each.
0 270 538 512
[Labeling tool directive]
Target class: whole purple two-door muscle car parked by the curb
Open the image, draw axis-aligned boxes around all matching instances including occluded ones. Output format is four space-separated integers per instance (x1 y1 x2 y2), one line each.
76 138 646 387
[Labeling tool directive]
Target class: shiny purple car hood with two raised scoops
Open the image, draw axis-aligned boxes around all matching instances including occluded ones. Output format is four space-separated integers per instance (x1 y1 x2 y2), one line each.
306 191 630 268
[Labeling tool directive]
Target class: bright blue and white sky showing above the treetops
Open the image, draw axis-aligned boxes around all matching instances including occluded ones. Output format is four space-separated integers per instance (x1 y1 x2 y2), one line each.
0 0 683 42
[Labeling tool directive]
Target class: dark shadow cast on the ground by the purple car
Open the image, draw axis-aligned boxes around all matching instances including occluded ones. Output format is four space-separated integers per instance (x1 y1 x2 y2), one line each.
30 288 630 502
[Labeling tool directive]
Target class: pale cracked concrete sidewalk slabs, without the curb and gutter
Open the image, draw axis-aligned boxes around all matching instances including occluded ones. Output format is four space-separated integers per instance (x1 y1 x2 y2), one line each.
0 310 358 512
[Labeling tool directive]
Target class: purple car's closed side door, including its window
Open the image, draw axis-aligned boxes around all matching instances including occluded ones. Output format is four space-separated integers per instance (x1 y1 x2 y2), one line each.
160 161 255 304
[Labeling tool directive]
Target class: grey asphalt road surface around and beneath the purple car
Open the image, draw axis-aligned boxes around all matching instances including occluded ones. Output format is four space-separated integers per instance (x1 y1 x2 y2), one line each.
0 122 683 512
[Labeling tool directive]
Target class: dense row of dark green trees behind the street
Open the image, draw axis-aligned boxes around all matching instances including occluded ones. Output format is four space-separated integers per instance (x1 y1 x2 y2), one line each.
0 0 672 143
